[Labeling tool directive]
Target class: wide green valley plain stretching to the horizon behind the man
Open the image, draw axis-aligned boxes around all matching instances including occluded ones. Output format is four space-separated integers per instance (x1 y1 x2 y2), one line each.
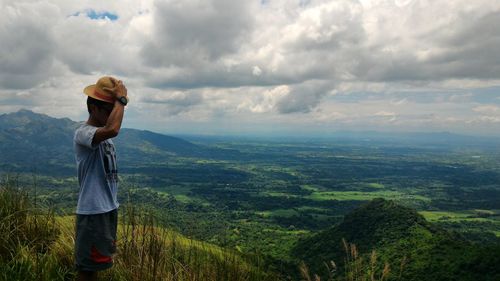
0 109 500 278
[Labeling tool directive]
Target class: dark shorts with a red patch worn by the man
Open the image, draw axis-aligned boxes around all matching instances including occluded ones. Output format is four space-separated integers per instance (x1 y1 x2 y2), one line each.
75 209 118 271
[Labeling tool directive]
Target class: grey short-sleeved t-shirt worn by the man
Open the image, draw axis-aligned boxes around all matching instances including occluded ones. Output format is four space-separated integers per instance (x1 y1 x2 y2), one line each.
73 123 119 215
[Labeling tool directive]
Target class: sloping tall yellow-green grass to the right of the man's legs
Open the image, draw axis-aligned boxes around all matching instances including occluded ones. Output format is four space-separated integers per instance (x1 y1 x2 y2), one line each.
100 201 278 281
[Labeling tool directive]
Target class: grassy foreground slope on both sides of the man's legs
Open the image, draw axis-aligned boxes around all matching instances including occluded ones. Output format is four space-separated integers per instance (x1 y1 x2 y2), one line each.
0 177 279 281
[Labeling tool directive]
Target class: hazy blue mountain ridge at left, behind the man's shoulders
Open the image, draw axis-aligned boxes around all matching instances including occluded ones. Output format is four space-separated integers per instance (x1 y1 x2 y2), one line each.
0 110 205 175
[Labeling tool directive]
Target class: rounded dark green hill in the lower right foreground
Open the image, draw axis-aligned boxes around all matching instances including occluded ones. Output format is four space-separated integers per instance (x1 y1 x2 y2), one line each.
292 199 500 281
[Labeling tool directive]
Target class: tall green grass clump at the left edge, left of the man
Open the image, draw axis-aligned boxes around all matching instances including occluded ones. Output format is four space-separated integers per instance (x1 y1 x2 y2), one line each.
0 177 70 281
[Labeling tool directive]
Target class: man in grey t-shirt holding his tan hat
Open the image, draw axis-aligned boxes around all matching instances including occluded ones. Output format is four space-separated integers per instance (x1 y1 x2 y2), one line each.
73 77 128 280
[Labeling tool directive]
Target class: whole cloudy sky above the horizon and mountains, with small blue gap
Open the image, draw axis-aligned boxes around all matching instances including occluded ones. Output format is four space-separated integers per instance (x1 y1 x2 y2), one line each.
0 0 500 136
